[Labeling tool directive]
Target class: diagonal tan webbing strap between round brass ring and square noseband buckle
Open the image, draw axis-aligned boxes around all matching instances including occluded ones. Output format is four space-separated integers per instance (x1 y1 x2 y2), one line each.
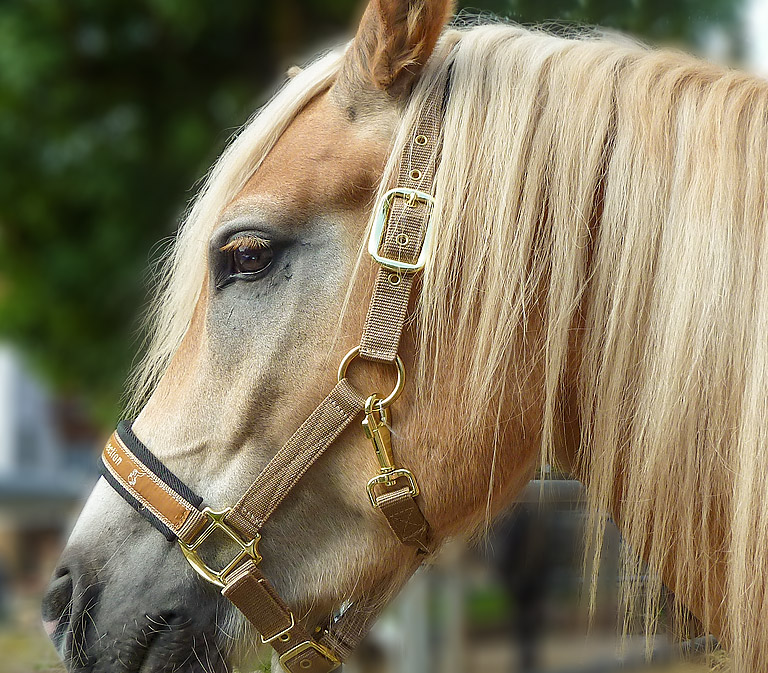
226 379 365 538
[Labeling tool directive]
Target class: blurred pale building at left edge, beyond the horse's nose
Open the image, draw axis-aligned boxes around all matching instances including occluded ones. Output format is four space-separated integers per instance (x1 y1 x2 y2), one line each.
0 345 98 589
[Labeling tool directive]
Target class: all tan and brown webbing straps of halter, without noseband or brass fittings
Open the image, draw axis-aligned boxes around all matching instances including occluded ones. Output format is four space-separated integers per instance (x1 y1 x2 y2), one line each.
222 87 443 660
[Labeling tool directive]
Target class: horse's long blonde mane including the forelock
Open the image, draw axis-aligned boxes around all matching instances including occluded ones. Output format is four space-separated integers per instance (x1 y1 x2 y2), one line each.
134 18 768 671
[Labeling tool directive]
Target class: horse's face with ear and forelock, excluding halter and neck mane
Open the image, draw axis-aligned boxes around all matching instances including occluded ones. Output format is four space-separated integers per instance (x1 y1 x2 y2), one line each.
43 0 544 673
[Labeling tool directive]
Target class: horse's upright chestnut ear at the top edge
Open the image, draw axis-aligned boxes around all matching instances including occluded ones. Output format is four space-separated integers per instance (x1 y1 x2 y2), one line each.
340 0 454 97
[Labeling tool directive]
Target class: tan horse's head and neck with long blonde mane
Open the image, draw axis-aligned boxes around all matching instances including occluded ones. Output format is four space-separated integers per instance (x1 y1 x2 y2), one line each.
43 0 768 673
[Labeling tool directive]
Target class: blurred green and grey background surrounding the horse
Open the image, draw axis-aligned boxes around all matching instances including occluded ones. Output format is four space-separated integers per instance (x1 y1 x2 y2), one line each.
0 0 768 673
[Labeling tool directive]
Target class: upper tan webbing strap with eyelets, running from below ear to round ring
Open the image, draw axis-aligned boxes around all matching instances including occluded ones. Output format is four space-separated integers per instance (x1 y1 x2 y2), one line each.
360 87 444 362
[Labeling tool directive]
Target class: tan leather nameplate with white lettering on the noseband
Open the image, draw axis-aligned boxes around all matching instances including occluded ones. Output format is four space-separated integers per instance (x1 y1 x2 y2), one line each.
101 433 190 533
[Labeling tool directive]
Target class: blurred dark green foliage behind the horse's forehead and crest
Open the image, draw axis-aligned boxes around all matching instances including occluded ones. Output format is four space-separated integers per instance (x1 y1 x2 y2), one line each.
0 0 738 422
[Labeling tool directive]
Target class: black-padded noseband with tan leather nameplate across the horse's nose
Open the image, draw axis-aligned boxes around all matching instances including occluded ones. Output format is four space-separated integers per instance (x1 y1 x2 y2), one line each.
100 421 205 542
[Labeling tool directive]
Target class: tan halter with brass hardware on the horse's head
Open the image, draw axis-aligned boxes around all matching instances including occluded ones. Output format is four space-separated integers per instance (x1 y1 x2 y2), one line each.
101 77 449 673
